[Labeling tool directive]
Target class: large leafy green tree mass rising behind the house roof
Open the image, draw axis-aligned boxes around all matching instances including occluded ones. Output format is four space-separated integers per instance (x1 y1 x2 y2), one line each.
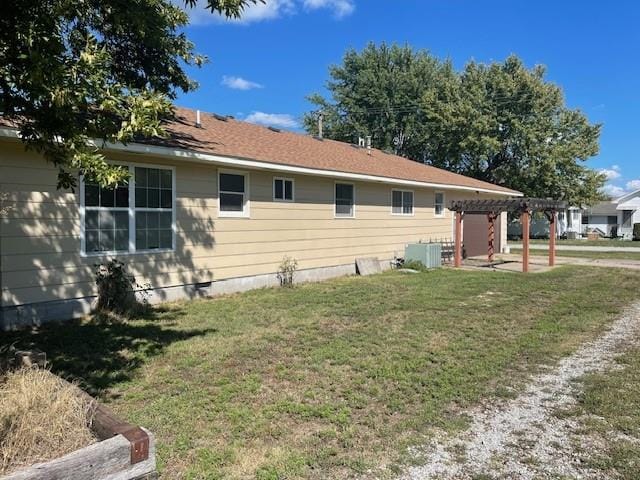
305 44 605 204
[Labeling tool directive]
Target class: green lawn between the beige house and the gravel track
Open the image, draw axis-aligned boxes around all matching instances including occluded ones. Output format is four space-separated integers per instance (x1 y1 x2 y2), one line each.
7 266 640 480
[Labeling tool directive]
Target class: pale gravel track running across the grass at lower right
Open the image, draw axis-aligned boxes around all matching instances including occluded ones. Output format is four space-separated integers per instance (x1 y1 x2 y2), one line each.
401 303 640 480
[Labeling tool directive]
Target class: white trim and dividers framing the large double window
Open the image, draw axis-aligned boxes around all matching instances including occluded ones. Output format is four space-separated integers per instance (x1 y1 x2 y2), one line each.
80 162 176 257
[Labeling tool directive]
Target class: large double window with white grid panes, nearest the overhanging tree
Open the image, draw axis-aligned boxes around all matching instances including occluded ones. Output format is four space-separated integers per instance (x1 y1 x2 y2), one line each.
80 166 175 255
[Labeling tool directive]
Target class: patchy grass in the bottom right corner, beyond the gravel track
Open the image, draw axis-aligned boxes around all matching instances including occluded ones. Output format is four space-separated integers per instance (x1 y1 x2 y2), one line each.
574 348 640 480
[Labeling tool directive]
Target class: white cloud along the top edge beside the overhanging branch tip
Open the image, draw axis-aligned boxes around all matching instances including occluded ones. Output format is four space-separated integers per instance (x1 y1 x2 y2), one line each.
180 0 355 25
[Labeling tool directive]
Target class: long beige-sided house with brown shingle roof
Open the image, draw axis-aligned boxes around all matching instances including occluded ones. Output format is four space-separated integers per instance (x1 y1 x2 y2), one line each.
0 109 520 327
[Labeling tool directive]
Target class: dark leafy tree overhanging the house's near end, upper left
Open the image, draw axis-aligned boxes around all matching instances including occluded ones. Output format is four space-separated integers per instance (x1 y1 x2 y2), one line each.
0 0 262 188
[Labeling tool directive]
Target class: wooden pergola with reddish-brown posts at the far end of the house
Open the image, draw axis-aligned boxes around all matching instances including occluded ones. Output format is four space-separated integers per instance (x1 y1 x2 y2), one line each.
451 198 567 273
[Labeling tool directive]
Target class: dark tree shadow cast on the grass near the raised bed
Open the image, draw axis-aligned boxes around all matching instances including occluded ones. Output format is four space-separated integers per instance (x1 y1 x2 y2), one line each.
2 307 216 398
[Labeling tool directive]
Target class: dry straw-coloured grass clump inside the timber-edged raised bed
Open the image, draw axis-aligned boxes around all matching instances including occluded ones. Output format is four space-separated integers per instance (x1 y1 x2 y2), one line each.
0 368 96 475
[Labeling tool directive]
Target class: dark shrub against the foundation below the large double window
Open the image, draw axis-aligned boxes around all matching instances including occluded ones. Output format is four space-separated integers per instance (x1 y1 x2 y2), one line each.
95 260 150 315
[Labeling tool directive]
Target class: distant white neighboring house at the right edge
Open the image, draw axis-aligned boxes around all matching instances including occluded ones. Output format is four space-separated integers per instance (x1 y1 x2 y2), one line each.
582 190 640 239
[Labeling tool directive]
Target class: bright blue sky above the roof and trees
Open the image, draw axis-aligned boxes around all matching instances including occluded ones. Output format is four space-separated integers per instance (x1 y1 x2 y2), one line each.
177 0 640 196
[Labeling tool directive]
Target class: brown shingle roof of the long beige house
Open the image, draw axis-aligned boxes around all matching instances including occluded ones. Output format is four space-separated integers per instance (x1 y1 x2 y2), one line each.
160 108 519 195
